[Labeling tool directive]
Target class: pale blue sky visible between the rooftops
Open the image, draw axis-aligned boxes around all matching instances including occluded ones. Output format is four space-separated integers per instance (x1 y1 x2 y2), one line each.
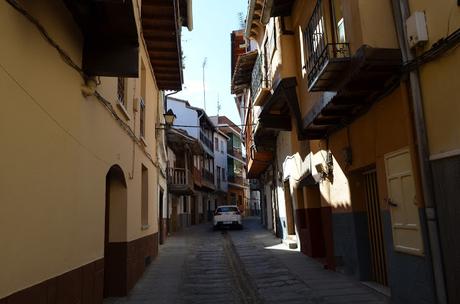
174 0 248 124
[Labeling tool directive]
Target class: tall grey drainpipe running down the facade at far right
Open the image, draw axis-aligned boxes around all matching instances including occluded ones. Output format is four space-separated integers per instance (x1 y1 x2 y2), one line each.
392 0 447 304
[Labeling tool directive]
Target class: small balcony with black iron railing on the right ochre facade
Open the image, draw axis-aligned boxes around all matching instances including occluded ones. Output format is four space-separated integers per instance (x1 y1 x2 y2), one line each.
307 43 351 91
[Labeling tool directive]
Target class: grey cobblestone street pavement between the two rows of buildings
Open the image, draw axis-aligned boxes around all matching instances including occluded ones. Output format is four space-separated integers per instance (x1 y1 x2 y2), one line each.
104 218 388 304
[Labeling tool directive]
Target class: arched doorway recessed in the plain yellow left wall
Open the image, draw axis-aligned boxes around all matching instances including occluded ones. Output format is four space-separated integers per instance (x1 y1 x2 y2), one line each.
104 165 128 297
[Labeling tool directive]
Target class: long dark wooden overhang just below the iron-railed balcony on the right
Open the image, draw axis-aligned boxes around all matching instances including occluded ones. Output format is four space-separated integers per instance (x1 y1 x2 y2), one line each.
302 45 402 139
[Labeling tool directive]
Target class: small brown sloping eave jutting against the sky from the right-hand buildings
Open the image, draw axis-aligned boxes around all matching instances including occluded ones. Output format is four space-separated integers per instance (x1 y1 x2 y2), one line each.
232 51 258 94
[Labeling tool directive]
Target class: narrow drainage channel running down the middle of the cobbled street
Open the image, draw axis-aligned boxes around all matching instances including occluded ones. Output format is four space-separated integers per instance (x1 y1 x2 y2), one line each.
222 231 263 304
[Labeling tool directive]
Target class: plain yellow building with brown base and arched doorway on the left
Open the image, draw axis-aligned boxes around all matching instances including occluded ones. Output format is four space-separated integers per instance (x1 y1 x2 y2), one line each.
0 1 190 303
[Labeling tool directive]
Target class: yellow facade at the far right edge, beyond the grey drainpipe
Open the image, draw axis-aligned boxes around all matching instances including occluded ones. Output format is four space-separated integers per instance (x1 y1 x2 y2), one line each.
403 0 460 303
